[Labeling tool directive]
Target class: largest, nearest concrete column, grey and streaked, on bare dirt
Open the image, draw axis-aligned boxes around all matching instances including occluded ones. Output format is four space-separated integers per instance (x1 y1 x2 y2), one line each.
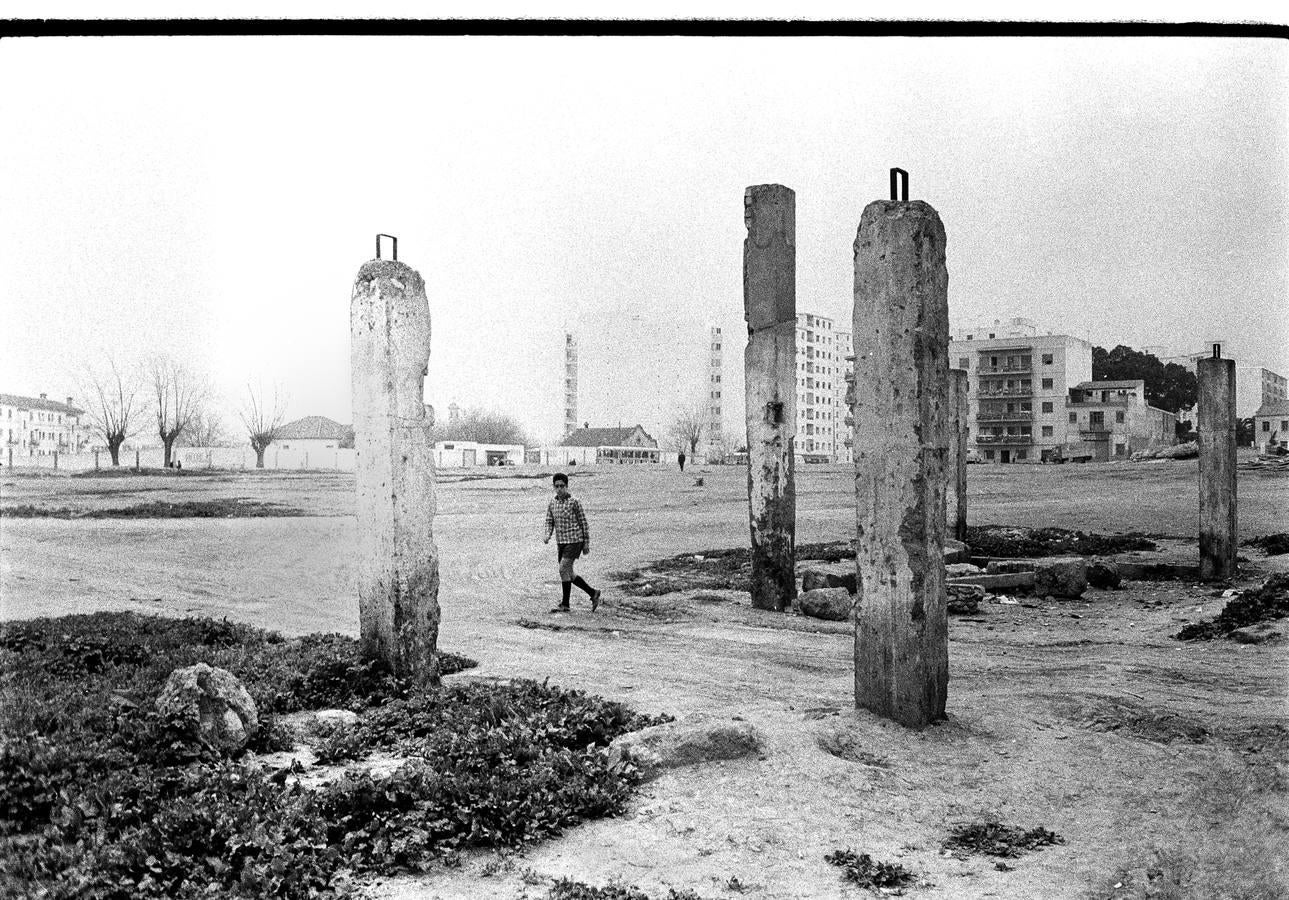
852 200 954 727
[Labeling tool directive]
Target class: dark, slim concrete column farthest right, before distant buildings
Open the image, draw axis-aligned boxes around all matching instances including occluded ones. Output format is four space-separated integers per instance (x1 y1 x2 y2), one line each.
1196 357 1239 582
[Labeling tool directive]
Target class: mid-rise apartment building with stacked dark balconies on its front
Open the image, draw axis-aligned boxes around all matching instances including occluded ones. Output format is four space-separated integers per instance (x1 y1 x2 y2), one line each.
949 318 1092 463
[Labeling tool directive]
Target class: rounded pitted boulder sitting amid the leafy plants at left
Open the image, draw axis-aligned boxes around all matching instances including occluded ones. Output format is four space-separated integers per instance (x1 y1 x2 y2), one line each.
156 663 259 753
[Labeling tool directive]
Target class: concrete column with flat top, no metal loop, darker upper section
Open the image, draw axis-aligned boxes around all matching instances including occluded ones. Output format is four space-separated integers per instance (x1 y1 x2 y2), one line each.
742 184 797 610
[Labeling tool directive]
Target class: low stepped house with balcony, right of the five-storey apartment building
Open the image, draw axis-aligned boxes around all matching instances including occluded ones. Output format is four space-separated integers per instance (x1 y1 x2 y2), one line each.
1062 378 1177 462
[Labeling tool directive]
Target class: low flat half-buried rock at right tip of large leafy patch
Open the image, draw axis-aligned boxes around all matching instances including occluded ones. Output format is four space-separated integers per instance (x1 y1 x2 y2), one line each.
608 721 762 781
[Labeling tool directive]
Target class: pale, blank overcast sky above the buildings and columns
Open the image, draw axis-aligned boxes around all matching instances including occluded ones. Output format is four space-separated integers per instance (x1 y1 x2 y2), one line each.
0 29 1289 438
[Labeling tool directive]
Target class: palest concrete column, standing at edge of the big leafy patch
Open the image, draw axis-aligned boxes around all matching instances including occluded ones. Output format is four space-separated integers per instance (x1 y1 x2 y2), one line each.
349 259 438 685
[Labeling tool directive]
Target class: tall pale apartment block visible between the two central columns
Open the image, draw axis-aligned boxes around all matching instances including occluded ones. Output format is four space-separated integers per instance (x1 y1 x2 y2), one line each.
797 312 849 463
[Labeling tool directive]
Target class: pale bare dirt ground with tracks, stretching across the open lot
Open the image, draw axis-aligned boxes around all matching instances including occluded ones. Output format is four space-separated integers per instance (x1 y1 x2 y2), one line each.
0 460 1289 900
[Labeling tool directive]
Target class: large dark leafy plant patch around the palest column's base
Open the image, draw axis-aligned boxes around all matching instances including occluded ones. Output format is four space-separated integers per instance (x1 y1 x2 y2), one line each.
0 614 659 900
